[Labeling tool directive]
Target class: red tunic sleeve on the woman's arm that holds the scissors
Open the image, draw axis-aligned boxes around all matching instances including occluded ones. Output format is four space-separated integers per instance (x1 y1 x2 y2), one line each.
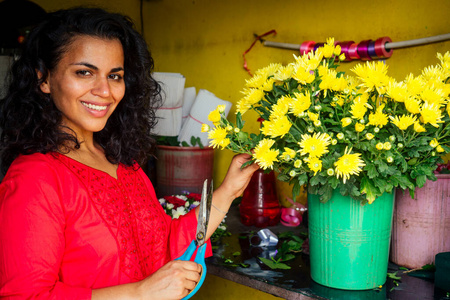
0 157 91 299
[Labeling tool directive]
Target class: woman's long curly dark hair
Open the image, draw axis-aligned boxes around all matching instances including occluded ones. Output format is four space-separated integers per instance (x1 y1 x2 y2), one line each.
0 7 161 172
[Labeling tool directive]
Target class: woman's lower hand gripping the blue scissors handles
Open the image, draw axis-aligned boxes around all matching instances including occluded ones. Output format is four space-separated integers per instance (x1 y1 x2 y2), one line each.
137 260 202 299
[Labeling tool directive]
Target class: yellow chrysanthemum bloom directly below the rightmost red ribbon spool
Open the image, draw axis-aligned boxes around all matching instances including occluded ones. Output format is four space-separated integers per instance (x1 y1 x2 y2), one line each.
352 61 390 94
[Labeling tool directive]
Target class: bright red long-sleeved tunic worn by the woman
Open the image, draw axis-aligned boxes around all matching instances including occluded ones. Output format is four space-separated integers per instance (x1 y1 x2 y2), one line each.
0 153 207 299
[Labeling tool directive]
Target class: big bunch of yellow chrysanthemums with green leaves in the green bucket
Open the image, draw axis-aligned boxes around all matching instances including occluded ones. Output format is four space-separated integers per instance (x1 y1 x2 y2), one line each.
202 38 450 203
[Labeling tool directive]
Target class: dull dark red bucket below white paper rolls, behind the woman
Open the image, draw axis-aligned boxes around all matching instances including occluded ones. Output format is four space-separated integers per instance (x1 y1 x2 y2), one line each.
156 146 214 197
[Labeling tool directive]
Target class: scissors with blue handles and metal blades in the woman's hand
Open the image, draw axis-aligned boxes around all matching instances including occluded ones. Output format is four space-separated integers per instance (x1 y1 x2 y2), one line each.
176 179 213 299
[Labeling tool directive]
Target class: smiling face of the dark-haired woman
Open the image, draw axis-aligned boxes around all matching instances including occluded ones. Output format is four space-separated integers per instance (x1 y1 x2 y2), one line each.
41 36 125 137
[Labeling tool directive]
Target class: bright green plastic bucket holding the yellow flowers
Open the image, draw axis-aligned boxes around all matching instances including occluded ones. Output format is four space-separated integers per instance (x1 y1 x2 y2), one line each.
308 191 394 290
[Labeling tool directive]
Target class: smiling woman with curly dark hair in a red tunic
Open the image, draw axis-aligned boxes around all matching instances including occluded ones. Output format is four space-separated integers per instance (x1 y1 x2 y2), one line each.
0 8 257 299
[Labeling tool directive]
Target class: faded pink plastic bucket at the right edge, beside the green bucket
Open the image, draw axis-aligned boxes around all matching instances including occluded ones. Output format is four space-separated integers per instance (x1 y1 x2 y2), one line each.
391 174 450 268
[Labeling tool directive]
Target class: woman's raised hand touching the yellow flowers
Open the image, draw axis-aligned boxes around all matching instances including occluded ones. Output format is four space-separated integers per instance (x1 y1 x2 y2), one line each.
217 154 259 201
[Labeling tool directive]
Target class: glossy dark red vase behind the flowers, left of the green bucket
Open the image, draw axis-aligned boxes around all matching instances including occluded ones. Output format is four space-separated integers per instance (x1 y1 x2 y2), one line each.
239 169 280 228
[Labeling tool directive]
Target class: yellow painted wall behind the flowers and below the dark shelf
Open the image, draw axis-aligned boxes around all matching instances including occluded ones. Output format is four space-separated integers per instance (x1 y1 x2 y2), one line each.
18 0 450 300
